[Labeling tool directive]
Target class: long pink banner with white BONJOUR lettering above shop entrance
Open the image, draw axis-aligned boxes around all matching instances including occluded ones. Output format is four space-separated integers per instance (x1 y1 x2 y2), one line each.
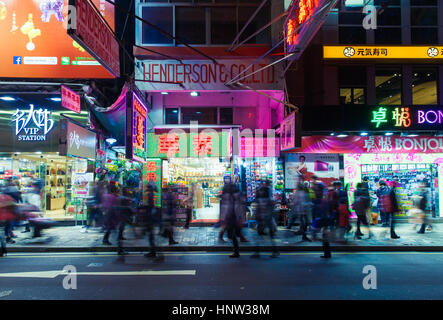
291 136 443 154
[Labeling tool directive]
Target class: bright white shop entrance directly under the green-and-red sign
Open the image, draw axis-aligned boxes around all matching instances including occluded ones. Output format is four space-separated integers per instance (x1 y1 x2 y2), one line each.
162 158 231 223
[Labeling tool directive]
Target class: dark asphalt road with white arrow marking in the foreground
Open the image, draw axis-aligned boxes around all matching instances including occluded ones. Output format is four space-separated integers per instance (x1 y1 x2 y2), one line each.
0 252 443 300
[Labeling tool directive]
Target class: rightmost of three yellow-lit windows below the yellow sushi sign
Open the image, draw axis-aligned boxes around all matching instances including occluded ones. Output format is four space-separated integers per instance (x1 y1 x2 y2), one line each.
412 68 438 105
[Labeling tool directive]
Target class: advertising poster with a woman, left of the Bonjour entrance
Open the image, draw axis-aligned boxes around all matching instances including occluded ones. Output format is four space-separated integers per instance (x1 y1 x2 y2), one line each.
285 153 340 189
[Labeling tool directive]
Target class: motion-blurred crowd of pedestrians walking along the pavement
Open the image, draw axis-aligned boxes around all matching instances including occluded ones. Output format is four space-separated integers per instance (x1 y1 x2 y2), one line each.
0 176 429 258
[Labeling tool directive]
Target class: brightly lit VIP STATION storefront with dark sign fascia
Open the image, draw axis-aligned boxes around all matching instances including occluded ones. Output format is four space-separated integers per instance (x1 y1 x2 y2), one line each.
0 94 96 220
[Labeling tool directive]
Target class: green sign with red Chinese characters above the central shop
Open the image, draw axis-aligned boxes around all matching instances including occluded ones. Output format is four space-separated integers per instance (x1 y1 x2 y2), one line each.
147 130 232 158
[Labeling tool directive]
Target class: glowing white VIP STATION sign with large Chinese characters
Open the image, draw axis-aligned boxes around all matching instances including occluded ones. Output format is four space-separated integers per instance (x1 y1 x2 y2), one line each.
12 104 54 141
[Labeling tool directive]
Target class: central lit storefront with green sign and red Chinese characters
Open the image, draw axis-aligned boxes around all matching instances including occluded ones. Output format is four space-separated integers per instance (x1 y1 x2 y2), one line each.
147 130 232 223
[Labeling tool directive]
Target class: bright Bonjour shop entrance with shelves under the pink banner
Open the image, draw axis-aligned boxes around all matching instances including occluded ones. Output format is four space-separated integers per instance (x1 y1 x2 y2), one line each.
361 164 440 217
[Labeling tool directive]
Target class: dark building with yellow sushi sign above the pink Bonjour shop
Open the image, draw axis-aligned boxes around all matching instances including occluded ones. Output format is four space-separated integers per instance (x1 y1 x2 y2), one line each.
287 0 443 218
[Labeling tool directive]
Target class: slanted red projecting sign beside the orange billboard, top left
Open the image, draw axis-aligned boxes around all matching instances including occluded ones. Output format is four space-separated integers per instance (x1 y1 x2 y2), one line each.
67 0 120 77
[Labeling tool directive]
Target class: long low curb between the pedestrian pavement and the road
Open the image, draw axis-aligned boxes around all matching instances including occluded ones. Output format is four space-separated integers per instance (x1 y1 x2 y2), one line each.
7 245 443 253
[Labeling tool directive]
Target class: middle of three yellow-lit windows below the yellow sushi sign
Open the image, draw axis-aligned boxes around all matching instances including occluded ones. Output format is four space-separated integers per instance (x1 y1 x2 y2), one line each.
375 67 402 105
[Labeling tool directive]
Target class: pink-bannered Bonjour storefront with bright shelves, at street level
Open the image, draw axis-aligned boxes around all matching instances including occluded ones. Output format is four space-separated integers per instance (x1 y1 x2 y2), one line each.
286 135 443 217
